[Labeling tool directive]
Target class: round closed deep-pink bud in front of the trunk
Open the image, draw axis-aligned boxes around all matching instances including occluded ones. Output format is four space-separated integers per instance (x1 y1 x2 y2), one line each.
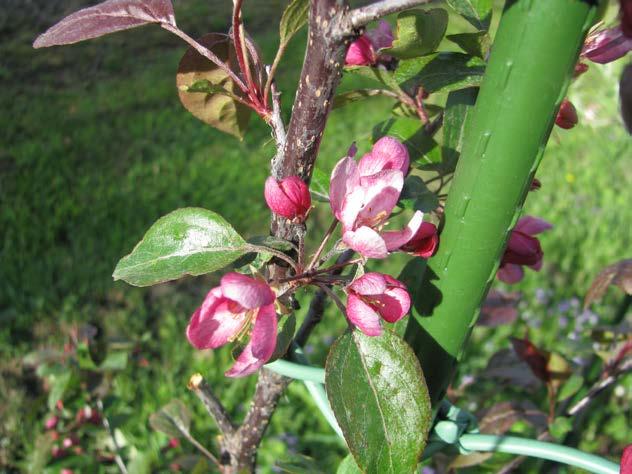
264 176 312 222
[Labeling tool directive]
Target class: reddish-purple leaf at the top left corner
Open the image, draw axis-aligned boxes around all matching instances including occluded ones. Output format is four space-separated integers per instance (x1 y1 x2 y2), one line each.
33 0 176 48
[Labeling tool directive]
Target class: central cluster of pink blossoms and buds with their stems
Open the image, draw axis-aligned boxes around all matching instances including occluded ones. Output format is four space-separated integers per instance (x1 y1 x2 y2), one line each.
186 137 439 377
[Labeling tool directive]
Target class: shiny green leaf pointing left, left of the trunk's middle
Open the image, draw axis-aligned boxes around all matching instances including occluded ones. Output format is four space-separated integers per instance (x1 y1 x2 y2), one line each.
113 207 248 286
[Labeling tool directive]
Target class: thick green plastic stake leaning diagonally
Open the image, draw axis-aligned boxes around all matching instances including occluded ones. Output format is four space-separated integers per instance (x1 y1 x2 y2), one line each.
406 0 597 404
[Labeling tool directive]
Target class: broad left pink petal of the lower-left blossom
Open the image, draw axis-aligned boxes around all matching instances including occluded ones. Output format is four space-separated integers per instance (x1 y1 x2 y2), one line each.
186 288 246 349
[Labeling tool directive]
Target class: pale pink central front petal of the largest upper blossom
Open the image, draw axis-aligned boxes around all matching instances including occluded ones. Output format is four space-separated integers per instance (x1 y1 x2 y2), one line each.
356 170 404 227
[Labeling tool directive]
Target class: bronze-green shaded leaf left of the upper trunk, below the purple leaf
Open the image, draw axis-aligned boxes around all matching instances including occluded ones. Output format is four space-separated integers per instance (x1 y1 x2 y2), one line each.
176 33 251 139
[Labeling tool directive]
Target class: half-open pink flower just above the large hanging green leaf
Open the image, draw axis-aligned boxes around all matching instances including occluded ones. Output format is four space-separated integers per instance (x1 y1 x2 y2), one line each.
346 272 410 336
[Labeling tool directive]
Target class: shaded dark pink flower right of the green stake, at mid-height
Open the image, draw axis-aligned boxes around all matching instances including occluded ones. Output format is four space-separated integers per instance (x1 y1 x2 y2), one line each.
497 216 553 284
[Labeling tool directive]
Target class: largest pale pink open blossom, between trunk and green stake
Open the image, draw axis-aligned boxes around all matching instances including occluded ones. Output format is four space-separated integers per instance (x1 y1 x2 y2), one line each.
329 137 423 258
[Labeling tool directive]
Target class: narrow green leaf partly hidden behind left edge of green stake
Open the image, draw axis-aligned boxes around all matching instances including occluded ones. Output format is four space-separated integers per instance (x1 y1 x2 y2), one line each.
442 87 478 173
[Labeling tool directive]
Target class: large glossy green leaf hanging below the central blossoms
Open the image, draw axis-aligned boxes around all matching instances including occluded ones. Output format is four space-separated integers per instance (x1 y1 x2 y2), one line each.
325 330 431 473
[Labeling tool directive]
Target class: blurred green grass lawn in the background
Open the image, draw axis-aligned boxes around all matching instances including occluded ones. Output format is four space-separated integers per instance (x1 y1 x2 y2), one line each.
0 0 632 472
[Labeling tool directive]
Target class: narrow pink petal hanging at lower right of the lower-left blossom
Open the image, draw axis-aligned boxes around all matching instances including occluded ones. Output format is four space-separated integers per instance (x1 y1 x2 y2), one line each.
225 304 277 377
